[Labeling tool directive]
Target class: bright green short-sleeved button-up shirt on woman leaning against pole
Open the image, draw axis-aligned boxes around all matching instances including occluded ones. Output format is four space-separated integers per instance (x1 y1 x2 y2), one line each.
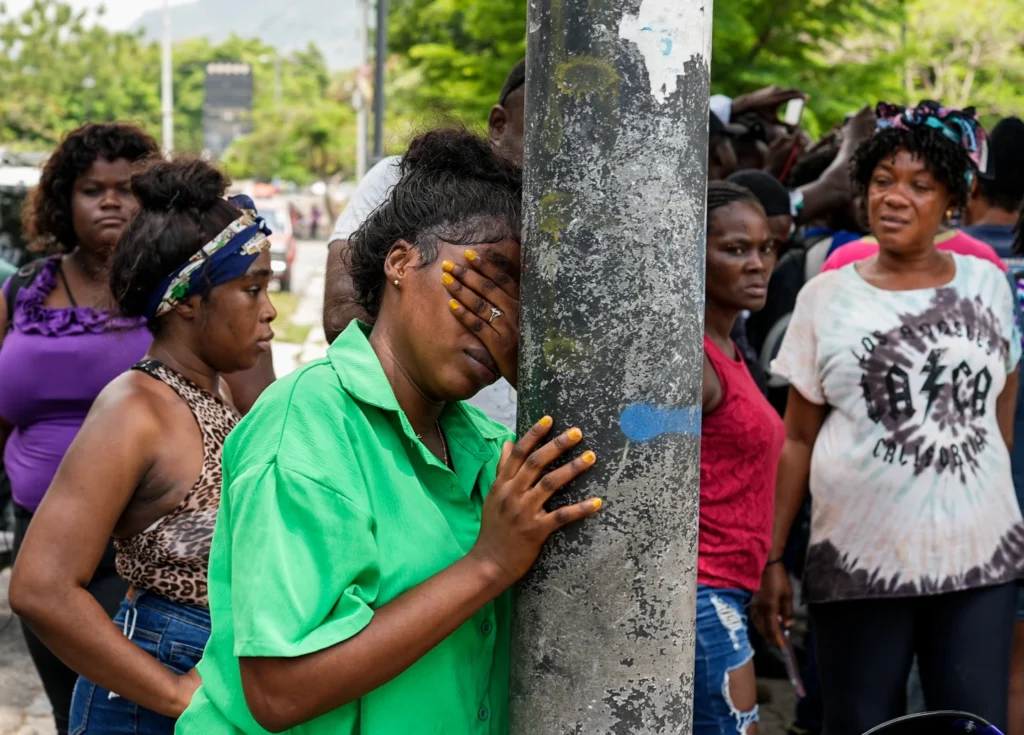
175 322 511 735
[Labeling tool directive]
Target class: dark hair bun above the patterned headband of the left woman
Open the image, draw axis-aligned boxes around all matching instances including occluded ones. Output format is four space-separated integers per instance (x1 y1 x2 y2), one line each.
131 159 230 212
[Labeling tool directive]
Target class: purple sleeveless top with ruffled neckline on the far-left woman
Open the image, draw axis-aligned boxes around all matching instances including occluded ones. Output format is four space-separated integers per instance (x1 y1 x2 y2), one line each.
0 258 152 512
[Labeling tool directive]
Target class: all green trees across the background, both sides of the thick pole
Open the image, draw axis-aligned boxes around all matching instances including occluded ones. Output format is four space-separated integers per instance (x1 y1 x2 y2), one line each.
0 0 1024 182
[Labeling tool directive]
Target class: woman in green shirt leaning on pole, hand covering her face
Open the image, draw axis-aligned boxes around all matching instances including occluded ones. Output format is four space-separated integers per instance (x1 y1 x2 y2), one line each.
176 130 601 735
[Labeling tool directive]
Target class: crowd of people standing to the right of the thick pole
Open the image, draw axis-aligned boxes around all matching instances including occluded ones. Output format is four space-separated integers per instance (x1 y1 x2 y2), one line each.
694 90 1024 735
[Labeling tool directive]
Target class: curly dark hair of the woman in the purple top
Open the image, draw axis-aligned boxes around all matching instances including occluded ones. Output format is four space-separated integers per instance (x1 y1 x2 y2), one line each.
25 123 160 251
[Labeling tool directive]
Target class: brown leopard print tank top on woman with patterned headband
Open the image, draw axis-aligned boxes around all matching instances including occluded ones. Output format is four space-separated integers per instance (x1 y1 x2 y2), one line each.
116 360 241 607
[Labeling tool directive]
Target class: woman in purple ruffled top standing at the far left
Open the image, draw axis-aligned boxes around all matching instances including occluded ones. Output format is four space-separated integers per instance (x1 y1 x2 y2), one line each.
0 124 159 735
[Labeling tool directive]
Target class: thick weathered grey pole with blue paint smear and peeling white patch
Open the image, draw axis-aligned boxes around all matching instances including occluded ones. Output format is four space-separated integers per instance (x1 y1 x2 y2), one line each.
510 0 712 735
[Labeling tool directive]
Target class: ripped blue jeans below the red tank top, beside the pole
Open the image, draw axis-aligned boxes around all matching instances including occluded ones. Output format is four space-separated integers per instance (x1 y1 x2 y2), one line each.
693 585 758 735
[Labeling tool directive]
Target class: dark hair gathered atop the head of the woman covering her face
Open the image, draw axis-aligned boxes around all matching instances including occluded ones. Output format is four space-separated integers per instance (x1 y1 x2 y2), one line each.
401 128 521 192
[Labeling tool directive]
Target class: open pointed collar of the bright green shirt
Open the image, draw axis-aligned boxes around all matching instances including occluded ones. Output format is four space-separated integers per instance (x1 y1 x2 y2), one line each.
328 320 508 460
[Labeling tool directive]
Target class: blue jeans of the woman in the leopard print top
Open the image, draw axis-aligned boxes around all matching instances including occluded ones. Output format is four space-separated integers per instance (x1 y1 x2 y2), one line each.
70 592 210 735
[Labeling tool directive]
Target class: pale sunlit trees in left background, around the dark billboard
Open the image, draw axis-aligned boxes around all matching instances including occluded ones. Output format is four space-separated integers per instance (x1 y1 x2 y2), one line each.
0 0 355 183
